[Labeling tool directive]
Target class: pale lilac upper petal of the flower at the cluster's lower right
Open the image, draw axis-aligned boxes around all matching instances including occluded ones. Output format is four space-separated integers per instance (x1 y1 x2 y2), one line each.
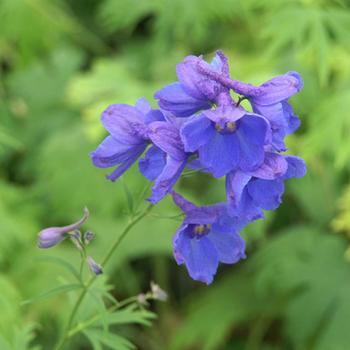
250 152 288 180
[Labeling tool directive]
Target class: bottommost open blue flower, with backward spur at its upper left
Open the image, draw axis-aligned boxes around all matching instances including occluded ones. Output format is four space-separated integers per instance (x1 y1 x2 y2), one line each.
173 192 247 284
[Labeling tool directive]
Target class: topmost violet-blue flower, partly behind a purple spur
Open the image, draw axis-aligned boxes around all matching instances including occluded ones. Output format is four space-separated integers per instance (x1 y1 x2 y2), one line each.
154 51 229 117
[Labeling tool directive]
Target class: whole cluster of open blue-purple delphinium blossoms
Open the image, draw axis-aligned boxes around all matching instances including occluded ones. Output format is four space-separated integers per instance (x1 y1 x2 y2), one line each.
91 51 306 284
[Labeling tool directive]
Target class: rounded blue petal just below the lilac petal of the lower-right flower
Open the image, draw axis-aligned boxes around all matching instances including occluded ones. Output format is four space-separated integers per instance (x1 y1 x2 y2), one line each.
248 179 284 210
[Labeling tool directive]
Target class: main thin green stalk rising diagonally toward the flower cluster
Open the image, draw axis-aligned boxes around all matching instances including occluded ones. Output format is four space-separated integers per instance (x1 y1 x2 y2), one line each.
55 204 153 350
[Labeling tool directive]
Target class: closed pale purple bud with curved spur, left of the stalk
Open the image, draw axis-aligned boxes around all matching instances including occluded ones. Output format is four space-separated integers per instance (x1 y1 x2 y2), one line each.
38 208 89 248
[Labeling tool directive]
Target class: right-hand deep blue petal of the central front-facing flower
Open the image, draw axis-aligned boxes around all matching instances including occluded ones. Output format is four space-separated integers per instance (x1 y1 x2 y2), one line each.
235 113 269 171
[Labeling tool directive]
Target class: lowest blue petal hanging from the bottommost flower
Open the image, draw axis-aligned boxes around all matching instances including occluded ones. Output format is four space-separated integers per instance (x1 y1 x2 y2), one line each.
174 233 219 284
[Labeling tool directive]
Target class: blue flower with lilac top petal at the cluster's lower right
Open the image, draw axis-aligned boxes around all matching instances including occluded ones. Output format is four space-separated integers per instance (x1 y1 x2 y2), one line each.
226 152 306 220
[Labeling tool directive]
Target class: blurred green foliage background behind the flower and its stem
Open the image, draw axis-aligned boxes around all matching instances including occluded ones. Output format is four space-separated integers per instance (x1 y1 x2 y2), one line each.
0 0 350 350
